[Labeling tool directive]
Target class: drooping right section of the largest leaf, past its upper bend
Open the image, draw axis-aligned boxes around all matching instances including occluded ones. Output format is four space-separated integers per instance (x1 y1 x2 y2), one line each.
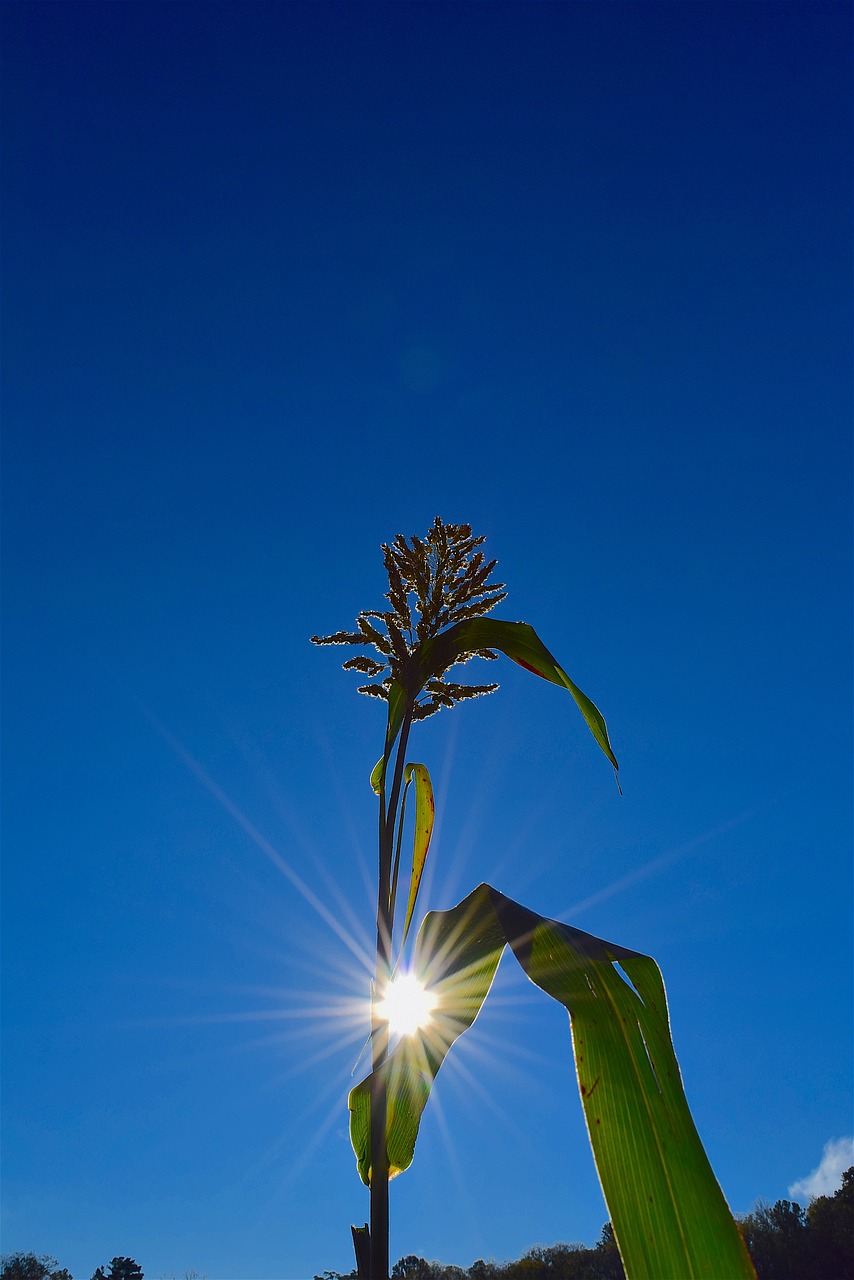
492 890 754 1280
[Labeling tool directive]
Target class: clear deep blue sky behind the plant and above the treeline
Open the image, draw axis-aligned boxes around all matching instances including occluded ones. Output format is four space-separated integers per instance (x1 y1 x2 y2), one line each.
3 0 853 1280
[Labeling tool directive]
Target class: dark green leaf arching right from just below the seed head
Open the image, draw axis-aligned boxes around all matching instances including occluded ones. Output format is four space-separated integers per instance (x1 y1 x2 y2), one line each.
385 618 620 769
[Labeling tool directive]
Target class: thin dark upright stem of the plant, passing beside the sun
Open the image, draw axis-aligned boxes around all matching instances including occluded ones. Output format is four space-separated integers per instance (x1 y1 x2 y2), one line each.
370 705 414 1280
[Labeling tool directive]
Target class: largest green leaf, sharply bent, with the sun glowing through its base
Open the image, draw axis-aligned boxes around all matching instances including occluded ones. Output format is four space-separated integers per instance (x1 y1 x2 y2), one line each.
350 884 754 1280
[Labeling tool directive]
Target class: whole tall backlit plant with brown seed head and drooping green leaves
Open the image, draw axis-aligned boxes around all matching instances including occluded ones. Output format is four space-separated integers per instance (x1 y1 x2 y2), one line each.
312 517 754 1280
